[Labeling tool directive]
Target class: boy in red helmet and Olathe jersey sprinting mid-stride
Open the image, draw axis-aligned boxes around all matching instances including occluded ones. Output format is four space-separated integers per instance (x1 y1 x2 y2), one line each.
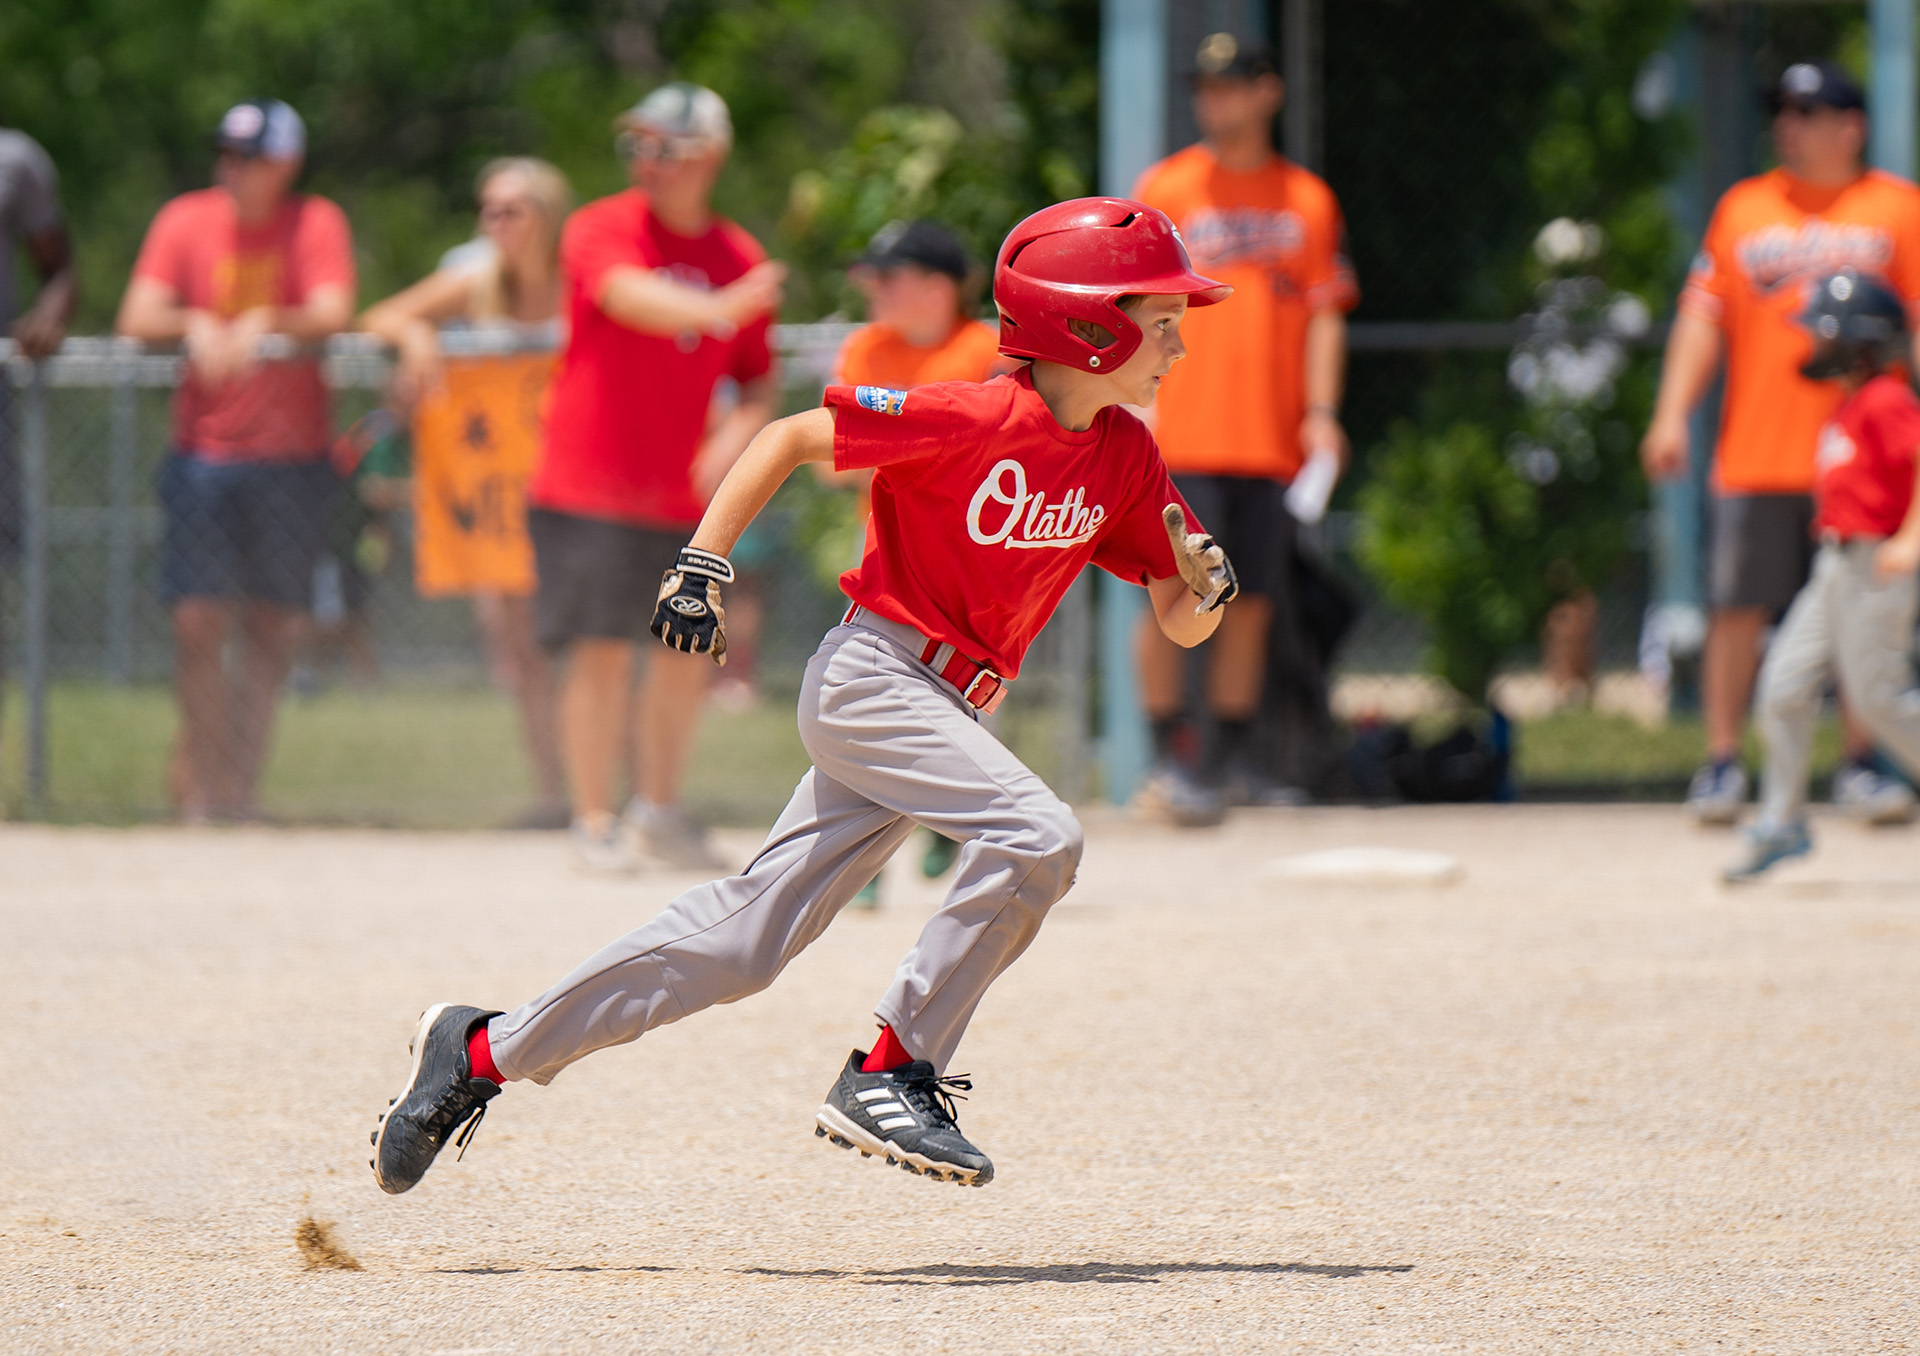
372 198 1236 1193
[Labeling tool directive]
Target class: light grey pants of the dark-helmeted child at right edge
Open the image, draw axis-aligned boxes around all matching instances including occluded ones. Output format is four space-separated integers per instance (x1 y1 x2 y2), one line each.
1761 538 1920 826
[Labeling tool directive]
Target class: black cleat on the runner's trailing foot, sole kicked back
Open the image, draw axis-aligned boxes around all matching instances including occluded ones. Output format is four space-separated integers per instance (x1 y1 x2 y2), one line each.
371 1003 499 1197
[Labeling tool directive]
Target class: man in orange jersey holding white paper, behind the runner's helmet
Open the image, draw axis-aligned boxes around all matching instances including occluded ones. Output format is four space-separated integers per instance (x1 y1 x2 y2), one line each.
1133 33 1359 824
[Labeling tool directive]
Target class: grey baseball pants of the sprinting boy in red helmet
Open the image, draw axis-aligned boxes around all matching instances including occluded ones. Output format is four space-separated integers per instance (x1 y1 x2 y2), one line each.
488 615 1081 1083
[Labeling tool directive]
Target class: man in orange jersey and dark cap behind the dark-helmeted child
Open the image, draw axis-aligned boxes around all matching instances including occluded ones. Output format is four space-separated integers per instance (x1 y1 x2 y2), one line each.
1643 61 1920 824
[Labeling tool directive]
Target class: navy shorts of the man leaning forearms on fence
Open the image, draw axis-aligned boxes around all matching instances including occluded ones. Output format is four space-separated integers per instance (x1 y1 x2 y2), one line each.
159 449 340 611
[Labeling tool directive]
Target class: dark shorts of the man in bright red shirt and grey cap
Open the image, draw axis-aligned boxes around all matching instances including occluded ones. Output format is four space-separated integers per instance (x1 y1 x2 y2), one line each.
526 509 695 651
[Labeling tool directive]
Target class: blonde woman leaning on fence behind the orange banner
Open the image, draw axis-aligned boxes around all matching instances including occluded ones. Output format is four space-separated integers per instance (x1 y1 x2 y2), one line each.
359 156 572 828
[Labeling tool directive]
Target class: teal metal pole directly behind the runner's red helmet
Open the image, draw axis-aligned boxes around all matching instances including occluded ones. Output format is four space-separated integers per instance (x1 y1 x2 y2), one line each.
1096 0 1167 805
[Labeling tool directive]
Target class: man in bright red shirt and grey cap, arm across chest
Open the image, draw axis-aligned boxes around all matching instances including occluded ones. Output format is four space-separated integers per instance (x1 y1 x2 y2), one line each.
528 83 785 870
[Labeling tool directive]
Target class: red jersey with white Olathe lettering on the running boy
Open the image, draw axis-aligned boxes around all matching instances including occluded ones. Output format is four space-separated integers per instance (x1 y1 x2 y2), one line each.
826 367 1204 678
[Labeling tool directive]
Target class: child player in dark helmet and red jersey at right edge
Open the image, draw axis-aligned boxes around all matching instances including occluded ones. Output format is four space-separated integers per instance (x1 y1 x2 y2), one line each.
1724 271 1920 882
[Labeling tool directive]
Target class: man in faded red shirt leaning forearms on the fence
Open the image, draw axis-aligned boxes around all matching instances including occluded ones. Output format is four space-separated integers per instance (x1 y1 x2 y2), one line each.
115 100 355 820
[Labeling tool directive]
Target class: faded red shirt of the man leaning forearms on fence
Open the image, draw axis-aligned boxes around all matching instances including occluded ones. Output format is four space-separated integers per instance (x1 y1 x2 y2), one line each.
132 188 355 461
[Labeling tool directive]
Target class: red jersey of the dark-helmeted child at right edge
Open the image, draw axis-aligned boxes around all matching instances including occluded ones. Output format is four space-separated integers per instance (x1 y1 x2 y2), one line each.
1812 373 1920 536
